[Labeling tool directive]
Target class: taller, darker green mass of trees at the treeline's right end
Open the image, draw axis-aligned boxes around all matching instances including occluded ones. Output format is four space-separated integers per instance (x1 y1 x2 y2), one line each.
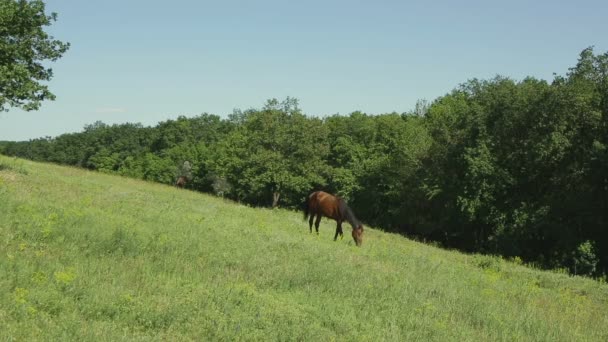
424 49 608 274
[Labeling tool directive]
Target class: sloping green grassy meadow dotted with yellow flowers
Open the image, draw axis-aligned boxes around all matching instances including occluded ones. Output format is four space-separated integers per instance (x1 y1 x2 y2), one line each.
0 156 608 341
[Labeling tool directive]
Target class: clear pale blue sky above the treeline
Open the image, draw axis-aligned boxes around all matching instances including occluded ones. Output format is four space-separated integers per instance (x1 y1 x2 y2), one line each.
0 0 608 140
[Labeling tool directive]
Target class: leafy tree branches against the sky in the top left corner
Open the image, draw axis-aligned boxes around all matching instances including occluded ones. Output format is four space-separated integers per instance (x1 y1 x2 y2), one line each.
0 0 69 111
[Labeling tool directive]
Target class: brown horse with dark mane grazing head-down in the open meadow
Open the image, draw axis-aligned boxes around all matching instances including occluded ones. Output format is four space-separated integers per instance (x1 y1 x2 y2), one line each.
304 191 363 247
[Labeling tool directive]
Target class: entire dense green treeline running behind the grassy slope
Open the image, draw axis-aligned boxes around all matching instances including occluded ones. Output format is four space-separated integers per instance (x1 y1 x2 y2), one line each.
0 48 608 276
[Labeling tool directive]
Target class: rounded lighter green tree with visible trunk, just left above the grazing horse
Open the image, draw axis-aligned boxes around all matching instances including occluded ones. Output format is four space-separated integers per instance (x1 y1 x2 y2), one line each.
213 98 328 207
